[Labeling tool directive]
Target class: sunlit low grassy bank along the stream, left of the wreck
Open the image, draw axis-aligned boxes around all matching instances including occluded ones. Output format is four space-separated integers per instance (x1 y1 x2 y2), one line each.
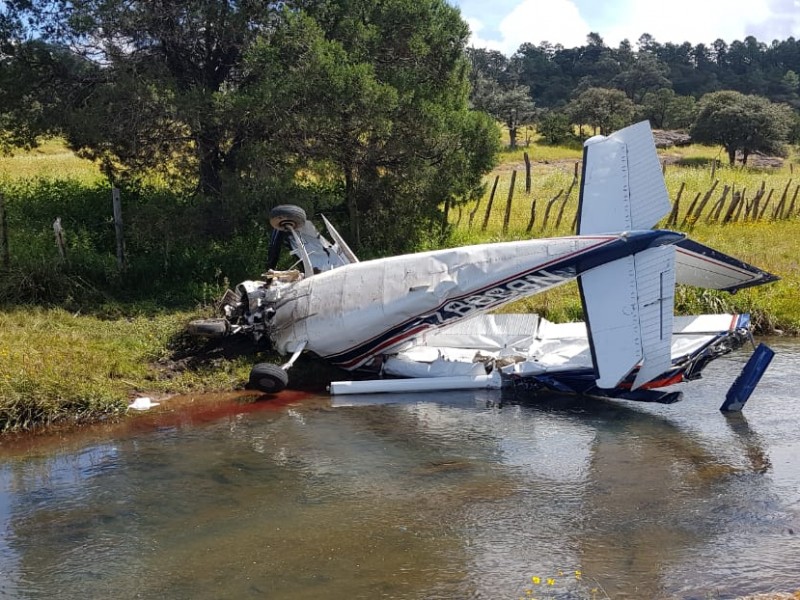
0 307 268 431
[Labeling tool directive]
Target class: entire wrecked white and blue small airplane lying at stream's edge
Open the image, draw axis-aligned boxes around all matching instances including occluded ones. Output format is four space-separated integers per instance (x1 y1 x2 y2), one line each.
189 122 777 411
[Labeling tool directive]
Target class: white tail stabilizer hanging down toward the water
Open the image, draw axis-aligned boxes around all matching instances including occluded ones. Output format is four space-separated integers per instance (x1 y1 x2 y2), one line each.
579 246 675 389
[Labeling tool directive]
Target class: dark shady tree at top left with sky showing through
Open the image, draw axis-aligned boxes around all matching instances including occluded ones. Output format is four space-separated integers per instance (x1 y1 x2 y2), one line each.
7 0 276 195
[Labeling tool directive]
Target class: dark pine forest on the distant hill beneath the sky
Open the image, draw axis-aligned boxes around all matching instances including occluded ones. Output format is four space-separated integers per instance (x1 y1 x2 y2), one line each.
469 33 800 109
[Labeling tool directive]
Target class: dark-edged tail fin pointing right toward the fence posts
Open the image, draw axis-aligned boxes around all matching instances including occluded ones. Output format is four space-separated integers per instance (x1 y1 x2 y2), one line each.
676 239 780 292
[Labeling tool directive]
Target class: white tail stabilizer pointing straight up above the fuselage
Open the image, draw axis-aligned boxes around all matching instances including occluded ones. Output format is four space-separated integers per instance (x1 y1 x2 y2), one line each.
578 121 670 235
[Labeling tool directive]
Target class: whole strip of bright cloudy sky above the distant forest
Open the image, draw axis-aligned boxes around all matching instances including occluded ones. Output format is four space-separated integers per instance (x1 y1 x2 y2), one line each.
449 0 800 56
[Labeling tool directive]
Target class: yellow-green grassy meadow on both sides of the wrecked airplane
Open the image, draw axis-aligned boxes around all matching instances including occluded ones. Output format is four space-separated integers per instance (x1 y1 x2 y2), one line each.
0 135 800 432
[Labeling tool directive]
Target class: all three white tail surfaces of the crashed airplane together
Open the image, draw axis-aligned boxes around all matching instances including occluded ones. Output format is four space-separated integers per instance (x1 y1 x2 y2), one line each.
578 121 777 389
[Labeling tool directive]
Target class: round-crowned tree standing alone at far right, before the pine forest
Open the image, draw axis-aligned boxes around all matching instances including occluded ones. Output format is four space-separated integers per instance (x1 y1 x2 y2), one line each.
690 91 792 165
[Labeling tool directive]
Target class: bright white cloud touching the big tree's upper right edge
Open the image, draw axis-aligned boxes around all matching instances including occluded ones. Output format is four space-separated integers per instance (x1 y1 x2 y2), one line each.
467 0 591 55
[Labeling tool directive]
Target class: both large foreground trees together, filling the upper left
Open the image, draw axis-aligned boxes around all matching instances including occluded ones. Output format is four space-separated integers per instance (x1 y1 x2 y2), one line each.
0 0 498 252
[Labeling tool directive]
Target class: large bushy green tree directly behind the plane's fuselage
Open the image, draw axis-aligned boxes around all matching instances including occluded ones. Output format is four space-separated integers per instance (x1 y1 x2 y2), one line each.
238 0 499 252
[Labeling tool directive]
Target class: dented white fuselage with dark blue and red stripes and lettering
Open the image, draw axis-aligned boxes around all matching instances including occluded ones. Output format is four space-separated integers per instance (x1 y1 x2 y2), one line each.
270 235 620 369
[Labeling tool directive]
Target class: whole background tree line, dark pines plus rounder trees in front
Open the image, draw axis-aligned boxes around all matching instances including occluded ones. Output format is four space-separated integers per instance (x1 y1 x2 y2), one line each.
467 33 800 164
